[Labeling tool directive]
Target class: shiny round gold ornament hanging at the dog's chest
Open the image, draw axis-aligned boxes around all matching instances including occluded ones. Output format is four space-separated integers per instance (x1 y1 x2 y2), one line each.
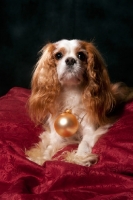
54 110 79 137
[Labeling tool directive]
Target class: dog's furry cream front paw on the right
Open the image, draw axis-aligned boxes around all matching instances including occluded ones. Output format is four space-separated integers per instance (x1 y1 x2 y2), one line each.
63 150 98 167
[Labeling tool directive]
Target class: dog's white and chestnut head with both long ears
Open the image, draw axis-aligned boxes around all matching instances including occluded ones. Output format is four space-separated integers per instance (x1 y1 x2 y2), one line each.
29 40 115 124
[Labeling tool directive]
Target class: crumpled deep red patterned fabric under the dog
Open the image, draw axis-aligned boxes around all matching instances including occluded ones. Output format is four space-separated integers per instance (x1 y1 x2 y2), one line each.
0 88 133 200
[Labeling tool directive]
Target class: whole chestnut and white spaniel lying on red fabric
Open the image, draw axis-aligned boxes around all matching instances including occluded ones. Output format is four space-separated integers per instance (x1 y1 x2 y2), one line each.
26 40 133 166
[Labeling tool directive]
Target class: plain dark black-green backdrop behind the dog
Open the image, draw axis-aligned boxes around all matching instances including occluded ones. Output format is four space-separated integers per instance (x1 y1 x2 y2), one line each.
0 0 133 95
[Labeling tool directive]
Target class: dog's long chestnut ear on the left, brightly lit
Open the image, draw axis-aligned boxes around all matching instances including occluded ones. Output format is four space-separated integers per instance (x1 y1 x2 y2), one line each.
28 43 60 124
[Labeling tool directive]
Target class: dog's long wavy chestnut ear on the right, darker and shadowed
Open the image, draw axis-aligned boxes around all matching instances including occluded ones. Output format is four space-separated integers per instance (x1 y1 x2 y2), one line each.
83 43 115 125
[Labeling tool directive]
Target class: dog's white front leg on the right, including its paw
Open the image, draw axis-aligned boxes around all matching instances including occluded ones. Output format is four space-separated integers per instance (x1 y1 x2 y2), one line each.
65 126 109 166
